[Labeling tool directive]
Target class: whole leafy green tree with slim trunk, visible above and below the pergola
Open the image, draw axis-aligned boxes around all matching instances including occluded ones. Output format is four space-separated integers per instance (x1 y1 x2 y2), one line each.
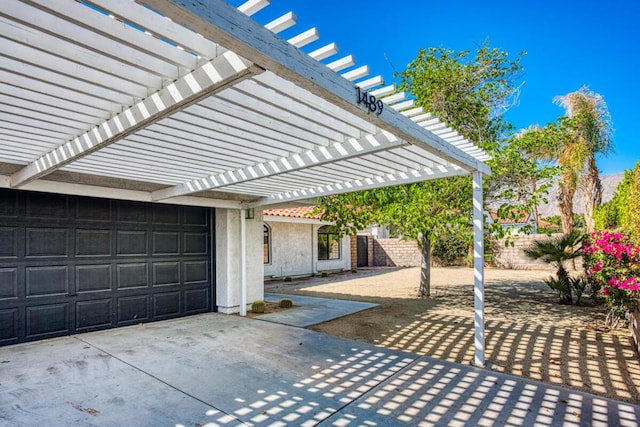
318 44 552 296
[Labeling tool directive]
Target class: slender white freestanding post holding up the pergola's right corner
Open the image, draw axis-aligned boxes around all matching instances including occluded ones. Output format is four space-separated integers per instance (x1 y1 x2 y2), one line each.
473 171 484 368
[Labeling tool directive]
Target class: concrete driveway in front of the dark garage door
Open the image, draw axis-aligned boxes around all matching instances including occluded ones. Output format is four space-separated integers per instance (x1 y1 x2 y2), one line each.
0 313 640 427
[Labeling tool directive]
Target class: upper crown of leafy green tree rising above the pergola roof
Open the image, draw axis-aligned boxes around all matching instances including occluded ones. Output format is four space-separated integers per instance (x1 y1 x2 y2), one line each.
398 43 525 152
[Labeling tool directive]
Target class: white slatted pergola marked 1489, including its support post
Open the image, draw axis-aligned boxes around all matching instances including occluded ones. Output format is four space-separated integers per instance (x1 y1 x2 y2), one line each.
0 0 490 366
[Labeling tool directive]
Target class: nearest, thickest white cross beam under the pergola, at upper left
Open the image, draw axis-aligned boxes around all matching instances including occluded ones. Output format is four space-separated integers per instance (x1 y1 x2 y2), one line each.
11 52 264 187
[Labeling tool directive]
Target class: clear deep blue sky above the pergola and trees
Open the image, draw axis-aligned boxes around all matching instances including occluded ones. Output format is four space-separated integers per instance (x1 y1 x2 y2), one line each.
230 0 640 175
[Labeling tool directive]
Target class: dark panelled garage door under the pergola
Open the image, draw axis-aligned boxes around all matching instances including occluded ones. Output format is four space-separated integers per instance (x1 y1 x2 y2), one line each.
0 189 214 345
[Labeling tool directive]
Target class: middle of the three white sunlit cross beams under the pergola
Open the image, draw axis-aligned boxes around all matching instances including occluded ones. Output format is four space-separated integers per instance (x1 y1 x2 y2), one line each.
153 132 403 200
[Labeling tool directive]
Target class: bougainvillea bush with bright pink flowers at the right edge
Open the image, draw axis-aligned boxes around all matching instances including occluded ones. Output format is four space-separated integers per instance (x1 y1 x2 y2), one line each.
584 231 640 318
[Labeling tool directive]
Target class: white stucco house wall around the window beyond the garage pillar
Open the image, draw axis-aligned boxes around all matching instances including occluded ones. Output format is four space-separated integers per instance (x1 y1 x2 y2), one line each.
264 220 351 277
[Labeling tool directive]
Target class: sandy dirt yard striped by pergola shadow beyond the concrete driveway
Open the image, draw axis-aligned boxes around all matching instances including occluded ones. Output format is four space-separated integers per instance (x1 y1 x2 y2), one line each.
265 267 640 404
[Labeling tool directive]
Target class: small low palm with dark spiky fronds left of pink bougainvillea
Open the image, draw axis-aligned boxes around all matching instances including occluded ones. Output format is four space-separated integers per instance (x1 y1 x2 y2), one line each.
524 230 584 304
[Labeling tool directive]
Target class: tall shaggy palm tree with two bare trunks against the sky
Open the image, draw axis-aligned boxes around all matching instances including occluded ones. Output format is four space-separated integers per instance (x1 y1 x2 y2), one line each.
554 86 613 234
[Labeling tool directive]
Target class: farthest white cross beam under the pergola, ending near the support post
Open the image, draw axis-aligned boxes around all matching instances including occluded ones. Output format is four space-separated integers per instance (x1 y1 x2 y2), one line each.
243 166 469 208
